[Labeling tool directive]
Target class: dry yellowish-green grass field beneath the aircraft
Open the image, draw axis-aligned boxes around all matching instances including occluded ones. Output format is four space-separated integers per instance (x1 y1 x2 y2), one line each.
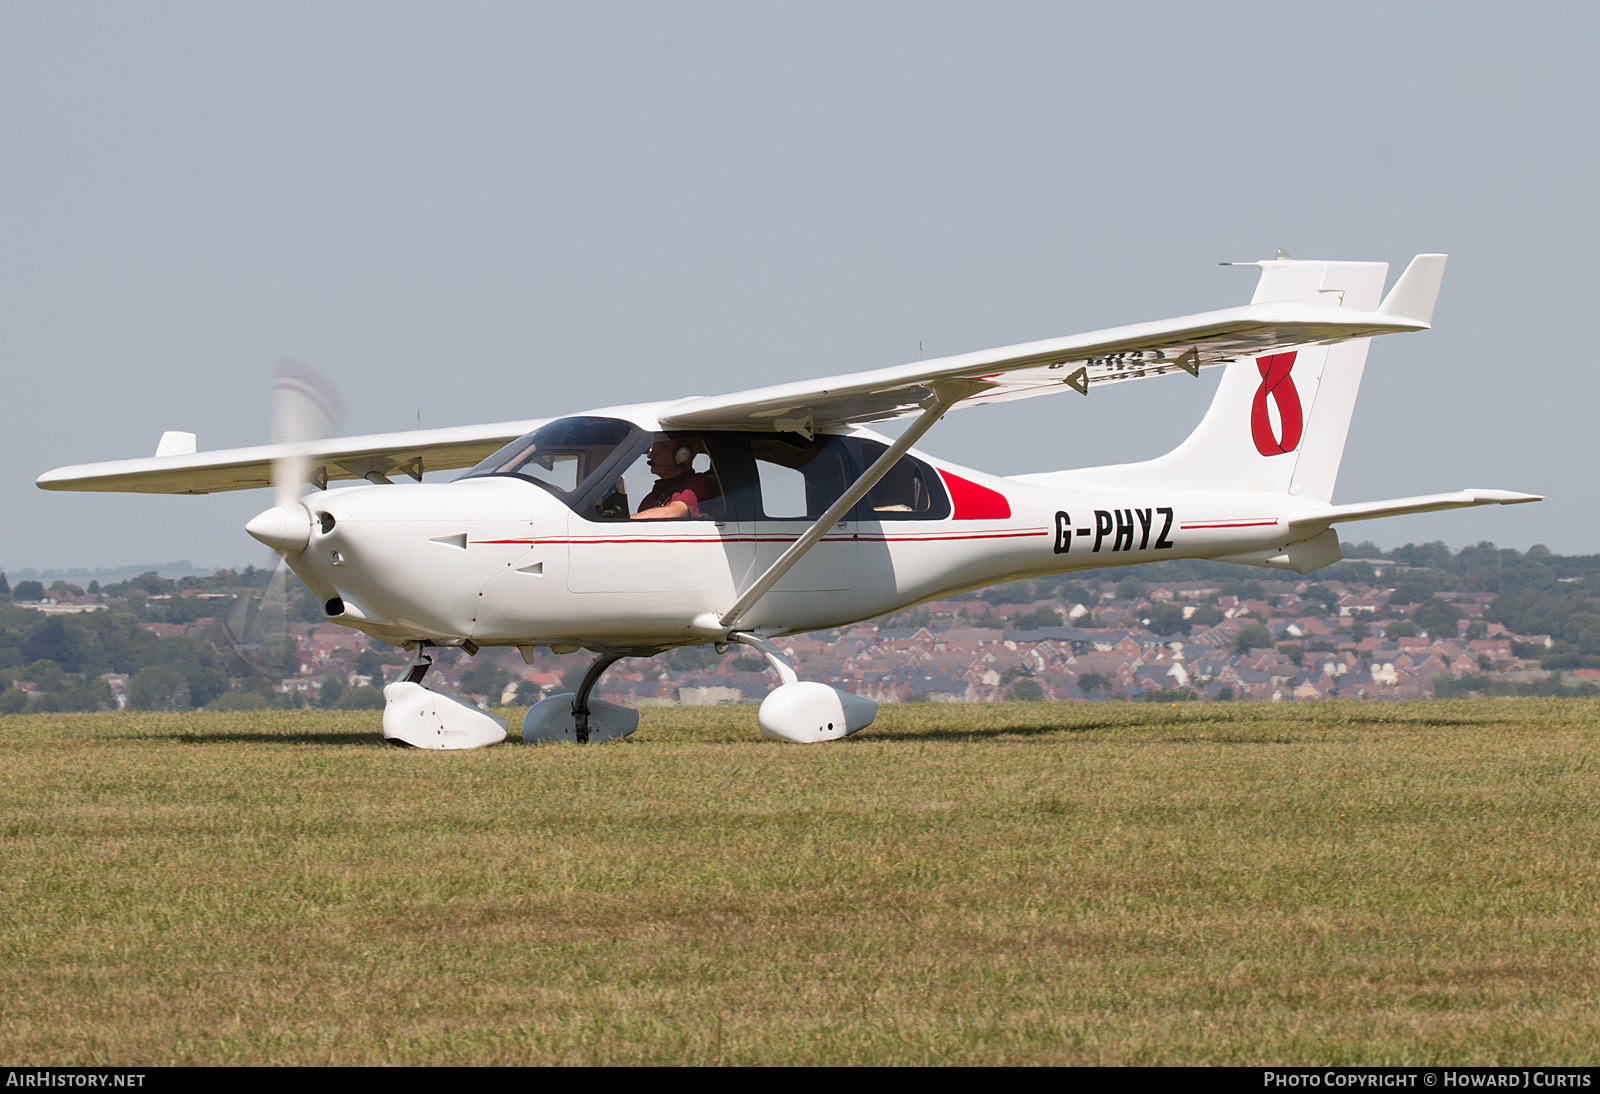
0 699 1600 1065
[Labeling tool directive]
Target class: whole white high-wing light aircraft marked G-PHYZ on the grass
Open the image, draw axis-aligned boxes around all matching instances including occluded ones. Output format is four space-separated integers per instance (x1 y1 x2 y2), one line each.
38 253 1539 749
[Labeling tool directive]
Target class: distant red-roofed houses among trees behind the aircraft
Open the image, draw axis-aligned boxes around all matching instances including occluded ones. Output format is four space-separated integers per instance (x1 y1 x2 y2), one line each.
3 562 1574 707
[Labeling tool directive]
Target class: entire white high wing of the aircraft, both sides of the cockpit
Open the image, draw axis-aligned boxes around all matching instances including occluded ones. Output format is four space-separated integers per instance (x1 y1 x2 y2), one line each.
37 254 1445 494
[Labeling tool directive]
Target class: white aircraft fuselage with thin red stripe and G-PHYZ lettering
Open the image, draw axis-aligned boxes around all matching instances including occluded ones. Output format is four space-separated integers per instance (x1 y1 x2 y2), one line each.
288 415 1336 648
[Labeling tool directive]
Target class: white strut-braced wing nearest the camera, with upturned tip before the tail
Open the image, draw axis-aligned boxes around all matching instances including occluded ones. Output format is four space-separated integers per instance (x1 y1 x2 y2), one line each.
661 254 1445 433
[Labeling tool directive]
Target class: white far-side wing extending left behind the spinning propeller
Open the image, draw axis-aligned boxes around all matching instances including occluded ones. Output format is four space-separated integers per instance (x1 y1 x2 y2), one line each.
37 417 550 494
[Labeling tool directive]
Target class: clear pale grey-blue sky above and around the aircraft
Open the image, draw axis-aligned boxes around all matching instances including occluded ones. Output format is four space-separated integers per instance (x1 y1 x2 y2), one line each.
0 2 1600 569
